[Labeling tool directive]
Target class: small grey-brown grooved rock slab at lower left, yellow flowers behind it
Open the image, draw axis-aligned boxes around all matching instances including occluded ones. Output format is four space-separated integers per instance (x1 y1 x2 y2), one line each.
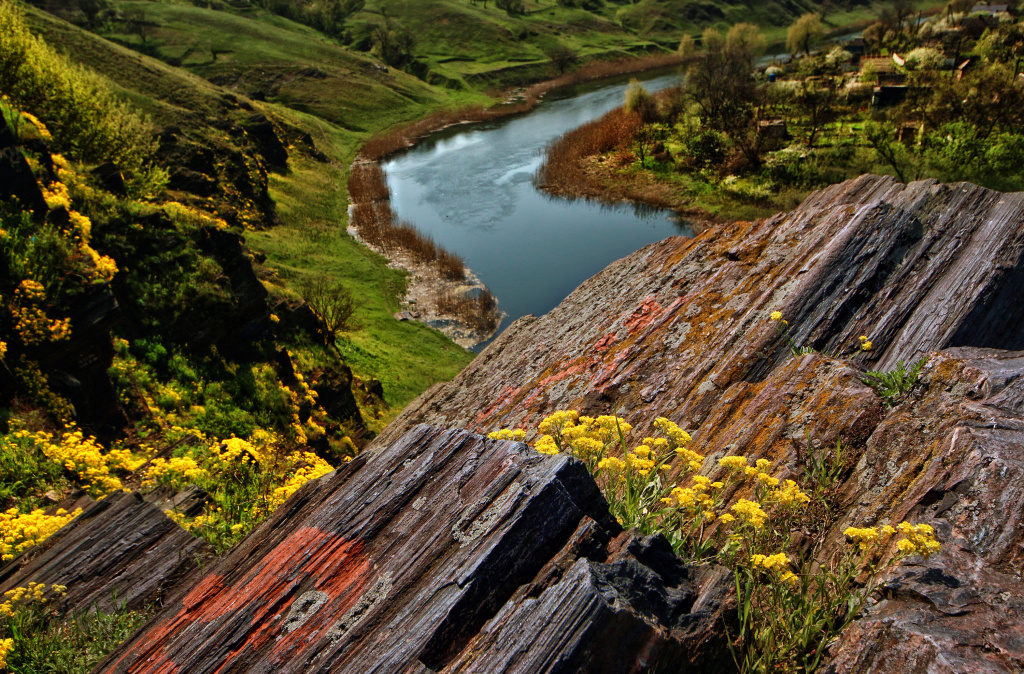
0 492 212 612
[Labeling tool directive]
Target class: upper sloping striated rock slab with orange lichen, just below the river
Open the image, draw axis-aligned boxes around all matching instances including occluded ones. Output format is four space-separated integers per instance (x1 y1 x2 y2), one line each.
380 175 1024 443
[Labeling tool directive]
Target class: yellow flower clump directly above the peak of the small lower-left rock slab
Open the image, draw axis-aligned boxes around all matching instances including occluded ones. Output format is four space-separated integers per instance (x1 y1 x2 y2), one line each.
36 429 145 495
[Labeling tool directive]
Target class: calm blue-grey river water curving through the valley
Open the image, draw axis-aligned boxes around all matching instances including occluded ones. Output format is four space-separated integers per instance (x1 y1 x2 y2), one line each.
384 73 692 350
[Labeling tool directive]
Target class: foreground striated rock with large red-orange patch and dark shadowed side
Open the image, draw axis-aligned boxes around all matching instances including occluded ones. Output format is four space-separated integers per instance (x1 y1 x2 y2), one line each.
96 426 732 674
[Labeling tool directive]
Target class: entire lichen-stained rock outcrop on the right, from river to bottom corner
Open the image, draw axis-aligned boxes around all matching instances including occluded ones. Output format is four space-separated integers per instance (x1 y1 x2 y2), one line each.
372 176 1024 673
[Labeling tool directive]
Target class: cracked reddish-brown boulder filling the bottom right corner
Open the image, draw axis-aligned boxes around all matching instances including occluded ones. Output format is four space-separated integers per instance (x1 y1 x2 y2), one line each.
825 349 1024 674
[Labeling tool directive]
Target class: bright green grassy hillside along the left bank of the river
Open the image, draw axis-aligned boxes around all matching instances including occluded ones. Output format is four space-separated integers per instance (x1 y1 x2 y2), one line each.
30 3 482 413
